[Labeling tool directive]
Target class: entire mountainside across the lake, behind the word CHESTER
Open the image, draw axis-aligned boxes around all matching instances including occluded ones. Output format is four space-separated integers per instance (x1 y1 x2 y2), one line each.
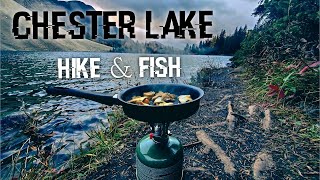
0 0 183 54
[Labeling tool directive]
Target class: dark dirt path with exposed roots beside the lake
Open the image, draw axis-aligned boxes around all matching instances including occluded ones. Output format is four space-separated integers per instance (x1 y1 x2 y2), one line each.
88 68 318 179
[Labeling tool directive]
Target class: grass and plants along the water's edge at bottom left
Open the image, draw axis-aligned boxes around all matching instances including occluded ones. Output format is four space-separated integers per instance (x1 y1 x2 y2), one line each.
11 107 139 180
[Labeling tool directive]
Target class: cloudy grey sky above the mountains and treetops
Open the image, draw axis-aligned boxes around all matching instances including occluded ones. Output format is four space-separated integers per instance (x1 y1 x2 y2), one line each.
82 0 259 48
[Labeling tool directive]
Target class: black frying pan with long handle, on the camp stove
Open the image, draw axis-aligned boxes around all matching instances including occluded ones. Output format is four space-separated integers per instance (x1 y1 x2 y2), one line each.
47 84 204 123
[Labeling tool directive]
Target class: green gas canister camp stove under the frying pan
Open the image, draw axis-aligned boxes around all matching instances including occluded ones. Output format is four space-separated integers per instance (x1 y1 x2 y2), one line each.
136 123 183 180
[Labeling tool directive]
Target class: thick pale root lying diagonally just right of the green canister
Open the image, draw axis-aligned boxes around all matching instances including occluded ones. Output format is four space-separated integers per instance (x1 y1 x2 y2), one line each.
196 130 236 176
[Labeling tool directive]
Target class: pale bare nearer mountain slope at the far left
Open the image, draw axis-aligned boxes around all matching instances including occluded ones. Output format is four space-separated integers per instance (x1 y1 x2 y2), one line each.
0 0 112 51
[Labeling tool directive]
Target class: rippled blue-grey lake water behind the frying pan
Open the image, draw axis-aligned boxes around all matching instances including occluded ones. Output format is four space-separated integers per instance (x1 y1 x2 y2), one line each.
0 52 231 176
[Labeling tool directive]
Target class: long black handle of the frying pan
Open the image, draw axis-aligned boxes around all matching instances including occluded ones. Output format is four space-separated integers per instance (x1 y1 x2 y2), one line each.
46 87 121 106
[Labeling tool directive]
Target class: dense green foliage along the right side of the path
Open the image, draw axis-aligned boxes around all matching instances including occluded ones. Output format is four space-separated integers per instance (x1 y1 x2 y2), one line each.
231 3 320 177
